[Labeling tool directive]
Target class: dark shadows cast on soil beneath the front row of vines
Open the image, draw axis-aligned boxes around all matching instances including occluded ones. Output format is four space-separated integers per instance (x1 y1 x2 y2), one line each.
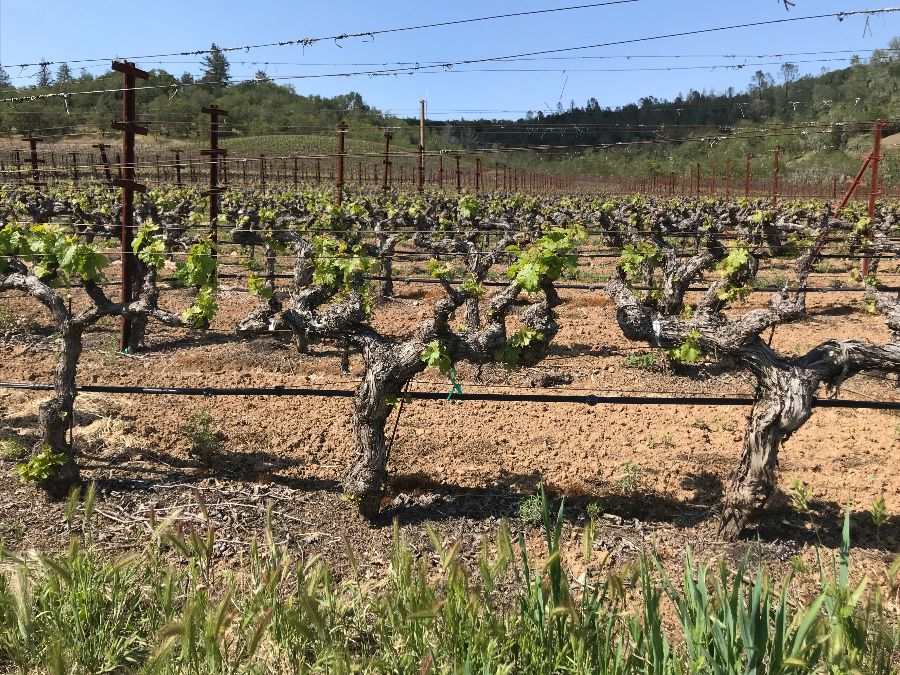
7 428 888 551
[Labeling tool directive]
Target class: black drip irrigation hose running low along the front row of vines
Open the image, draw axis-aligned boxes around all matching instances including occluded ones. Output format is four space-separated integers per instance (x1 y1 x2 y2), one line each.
0 382 900 410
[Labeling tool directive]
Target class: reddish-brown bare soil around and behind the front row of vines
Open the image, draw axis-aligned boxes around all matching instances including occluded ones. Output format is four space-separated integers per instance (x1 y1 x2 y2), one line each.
0 266 900 609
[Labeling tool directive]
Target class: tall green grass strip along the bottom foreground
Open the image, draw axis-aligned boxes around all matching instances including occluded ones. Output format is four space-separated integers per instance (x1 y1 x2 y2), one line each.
0 492 900 675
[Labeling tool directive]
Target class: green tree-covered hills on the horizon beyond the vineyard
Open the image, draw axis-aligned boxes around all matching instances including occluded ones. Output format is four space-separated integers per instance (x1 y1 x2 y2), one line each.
0 38 900 181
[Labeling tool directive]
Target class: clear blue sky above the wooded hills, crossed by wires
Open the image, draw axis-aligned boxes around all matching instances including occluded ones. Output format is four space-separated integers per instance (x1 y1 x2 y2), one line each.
0 0 900 119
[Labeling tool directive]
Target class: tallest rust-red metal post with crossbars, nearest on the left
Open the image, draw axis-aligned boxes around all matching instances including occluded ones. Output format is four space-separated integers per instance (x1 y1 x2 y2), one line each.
112 61 150 352
